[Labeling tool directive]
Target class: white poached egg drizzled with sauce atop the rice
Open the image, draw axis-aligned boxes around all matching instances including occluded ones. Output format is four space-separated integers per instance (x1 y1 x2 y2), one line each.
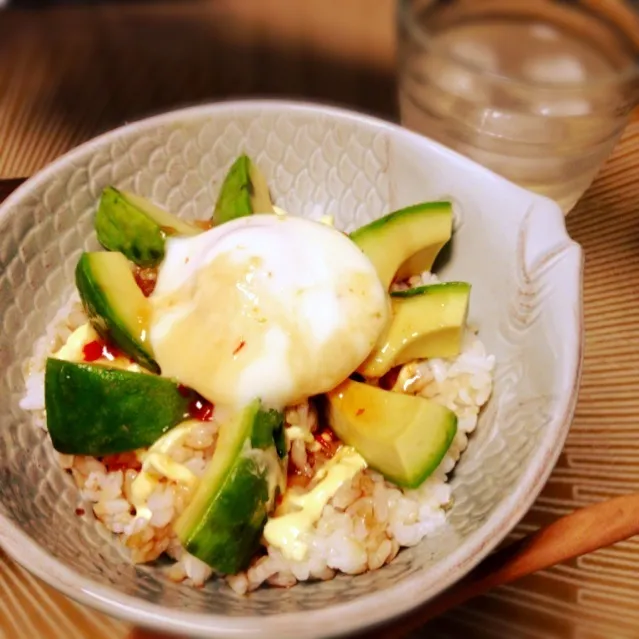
149 214 390 407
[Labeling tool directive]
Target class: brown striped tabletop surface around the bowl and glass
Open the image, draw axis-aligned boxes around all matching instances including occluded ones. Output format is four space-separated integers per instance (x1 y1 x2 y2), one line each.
0 0 639 639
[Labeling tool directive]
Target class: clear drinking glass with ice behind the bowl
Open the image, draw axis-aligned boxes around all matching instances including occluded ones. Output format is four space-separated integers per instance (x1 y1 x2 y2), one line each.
398 0 639 213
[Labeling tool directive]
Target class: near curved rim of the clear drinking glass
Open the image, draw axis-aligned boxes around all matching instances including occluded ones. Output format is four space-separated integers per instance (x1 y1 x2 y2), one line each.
397 0 639 92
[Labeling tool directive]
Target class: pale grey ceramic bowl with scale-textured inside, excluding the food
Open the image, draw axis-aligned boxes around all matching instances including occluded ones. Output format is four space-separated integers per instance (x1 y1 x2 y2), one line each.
0 101 582 638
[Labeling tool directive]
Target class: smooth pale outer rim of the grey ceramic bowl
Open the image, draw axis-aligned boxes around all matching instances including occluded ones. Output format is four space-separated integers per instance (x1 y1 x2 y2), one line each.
0 99 584 639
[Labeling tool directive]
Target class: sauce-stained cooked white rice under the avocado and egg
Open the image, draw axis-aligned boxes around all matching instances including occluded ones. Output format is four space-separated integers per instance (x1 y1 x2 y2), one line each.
21 273 494 594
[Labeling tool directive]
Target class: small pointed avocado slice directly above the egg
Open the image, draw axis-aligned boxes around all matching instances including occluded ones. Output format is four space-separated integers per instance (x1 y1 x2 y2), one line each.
212 155 274 225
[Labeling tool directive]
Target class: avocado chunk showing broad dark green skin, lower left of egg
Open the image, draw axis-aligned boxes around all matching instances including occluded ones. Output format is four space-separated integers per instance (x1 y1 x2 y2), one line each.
44 358 196 455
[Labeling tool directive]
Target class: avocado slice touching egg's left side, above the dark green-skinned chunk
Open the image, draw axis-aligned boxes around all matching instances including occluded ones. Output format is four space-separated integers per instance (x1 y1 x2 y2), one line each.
75 251 160 373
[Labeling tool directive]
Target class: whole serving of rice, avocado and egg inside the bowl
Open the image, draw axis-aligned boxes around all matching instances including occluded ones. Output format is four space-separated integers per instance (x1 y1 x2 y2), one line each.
17 156 494 594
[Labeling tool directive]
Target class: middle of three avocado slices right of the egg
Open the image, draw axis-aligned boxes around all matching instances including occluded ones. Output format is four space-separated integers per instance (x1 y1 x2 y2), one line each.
358 282 470 377
